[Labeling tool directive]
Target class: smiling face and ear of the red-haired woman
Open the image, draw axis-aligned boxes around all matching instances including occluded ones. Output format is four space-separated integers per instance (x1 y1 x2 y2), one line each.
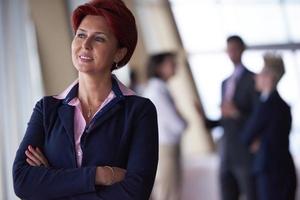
72 15 127 74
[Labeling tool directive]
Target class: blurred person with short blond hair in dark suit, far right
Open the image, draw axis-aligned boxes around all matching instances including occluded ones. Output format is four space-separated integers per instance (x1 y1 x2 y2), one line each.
242 53 296 200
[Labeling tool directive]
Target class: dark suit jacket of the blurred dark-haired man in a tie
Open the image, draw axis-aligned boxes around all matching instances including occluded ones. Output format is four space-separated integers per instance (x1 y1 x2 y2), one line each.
220 68 258 170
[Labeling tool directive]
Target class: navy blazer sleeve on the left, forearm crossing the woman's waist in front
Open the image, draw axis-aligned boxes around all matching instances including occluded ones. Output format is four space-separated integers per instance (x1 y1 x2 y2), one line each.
13 100 96 199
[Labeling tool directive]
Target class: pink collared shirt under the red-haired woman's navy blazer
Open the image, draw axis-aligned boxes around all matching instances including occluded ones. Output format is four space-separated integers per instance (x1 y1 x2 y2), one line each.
54 78 135 167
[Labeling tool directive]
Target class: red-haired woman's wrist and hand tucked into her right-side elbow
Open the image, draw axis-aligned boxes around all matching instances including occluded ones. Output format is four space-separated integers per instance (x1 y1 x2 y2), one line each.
95 166 126 186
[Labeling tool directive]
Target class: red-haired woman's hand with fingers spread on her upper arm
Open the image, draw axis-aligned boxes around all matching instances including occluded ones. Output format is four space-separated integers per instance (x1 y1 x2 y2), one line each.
25 145 49 167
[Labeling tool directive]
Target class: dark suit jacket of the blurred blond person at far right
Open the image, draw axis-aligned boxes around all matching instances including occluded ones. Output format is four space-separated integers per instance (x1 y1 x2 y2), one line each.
242 91 295 174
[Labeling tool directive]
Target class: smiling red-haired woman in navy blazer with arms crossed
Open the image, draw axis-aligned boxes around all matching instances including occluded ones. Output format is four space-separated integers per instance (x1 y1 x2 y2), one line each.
13 0 158 200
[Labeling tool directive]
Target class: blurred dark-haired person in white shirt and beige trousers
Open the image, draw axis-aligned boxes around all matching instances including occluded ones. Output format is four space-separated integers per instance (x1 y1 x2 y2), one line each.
144 52 186 200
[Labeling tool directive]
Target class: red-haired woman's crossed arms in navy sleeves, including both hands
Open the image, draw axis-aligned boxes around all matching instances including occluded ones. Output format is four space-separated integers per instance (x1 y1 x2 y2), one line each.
13 101 158 200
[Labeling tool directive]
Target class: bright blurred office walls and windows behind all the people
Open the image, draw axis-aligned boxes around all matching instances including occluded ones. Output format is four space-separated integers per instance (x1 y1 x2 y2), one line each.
0 0 300 200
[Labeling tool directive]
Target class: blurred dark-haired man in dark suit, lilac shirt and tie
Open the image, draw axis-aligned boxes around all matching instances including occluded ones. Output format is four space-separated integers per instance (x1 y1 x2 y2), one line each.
200 35 258 200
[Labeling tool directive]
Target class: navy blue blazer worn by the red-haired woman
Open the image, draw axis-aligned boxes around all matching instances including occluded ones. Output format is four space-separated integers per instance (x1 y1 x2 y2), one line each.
13 81 158 200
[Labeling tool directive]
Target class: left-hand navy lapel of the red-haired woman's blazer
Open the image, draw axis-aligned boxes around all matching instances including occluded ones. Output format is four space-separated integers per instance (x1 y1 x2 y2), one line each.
58 104 74 144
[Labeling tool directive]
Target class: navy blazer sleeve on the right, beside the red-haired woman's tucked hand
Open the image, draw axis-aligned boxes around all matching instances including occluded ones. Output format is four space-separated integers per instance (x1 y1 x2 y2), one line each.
98 100 158 200
